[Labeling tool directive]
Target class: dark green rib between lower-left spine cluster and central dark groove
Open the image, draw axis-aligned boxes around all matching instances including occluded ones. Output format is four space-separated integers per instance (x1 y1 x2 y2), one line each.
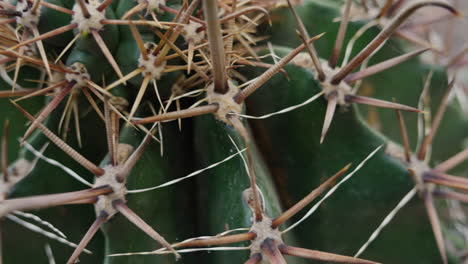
103 124 196 264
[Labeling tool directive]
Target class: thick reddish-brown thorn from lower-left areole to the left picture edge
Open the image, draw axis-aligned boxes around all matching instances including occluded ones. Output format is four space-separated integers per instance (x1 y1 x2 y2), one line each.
0 185 112 217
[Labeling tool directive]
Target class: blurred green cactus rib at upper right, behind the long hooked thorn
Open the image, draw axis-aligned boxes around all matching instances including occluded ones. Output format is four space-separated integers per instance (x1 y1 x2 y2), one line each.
266 0 468 171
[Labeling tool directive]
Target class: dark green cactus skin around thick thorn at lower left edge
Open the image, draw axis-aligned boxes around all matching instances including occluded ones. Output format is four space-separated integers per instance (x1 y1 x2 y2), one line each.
3 105 106 263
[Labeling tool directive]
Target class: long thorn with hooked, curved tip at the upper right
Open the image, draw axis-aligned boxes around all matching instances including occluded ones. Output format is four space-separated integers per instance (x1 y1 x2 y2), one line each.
331 0 459 85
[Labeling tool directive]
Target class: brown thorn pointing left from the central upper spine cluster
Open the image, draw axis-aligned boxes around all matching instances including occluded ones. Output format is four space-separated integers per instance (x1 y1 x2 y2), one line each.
132 104 219 125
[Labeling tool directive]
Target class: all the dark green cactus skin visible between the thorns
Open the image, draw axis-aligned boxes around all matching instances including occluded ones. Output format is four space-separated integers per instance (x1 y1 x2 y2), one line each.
0 0 468 264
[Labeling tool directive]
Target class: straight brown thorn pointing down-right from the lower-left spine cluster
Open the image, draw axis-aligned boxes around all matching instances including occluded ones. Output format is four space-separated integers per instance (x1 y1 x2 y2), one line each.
113 201 180 259
